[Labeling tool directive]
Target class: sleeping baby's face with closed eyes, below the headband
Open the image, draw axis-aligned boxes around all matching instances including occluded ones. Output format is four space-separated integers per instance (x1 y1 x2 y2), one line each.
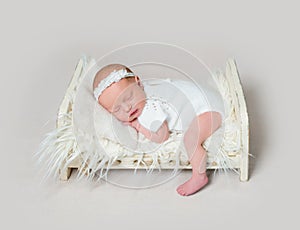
99 79 146 122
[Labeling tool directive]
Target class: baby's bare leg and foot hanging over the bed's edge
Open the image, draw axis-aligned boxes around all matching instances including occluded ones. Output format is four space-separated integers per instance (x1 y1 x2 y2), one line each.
177 112 222 196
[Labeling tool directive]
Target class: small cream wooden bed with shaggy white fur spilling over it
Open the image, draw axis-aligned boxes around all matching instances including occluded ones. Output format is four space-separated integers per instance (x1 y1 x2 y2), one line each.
37 56 249 181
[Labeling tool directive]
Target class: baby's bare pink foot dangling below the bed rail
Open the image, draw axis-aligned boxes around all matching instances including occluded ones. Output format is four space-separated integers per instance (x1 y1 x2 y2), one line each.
176 173 208 196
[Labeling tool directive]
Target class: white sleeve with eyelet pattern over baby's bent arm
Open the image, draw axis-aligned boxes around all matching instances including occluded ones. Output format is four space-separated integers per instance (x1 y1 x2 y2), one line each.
138 99 168 132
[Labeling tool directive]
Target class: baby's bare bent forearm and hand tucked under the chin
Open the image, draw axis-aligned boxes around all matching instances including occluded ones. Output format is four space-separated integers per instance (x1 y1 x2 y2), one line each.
131 119 170 143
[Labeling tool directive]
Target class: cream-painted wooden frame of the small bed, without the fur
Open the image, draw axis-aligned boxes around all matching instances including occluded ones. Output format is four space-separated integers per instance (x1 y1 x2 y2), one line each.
56 59 249 181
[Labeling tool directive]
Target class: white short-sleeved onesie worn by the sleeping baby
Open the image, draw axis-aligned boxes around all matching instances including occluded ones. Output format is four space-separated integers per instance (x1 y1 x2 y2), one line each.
138 78 224 132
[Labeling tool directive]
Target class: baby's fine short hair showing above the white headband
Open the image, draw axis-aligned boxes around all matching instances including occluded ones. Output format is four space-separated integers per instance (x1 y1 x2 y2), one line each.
93 64 135 91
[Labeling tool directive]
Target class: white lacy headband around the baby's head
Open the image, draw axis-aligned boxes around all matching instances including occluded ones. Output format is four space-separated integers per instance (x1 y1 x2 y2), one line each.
94 69 135 101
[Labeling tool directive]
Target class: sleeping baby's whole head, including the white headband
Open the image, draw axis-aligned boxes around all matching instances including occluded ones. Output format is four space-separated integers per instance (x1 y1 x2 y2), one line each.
93 64 146 122
